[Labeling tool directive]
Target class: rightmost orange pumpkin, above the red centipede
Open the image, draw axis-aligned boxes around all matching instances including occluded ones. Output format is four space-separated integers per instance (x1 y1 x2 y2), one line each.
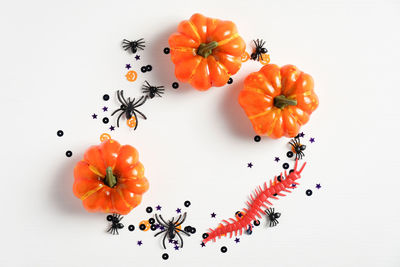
239 64 318 138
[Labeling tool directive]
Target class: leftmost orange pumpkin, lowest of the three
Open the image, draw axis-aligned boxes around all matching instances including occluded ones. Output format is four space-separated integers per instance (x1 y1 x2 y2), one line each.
73 139 149 214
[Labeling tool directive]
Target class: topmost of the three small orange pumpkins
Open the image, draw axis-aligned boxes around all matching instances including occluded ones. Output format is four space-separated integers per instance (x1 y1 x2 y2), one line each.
169 14 246 91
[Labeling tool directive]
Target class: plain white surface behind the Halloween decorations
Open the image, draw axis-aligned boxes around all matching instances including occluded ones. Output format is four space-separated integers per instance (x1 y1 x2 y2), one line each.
0 0 400 267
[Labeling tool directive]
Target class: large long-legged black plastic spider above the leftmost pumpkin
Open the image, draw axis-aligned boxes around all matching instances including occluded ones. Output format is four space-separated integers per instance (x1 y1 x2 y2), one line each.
111 90 147 130
